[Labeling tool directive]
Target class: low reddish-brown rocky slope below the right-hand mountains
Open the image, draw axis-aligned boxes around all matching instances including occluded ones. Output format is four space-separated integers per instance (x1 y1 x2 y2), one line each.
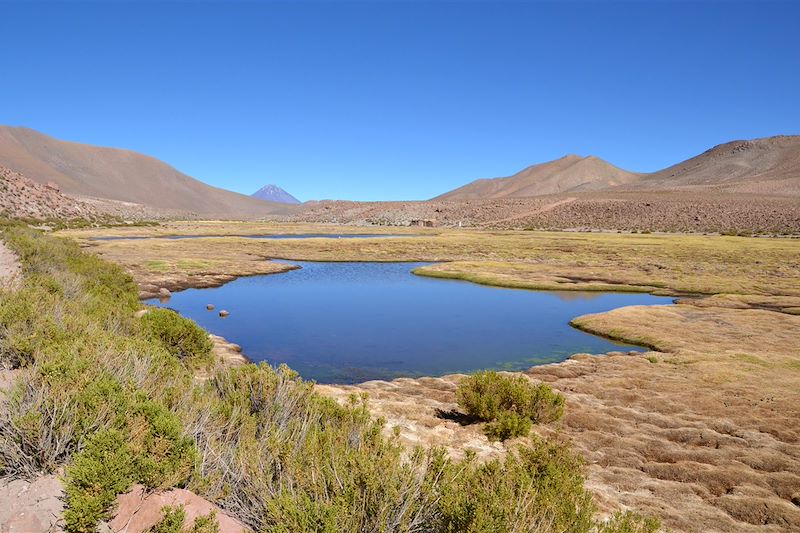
293 191 800 233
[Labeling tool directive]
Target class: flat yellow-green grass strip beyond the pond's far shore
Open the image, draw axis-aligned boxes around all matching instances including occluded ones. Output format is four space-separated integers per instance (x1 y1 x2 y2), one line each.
63 223 800 310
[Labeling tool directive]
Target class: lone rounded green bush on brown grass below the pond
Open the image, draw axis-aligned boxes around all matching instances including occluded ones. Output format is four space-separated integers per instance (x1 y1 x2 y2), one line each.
456 371 564 440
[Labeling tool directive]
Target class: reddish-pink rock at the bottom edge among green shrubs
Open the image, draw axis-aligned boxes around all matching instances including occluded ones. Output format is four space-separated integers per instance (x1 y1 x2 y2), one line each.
108 485 247 533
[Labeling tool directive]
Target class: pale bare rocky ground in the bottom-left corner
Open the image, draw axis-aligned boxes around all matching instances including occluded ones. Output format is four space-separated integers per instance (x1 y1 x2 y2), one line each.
0 476 64 533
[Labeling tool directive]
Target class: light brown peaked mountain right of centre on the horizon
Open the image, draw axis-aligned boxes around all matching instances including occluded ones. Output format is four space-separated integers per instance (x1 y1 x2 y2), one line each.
435 155 641 200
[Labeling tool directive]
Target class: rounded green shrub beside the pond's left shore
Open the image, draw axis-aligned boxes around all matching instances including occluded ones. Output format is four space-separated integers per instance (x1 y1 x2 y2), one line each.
141 309 213 363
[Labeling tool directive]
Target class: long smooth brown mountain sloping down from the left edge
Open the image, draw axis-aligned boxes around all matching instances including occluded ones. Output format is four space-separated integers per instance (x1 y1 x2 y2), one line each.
0 126 291 218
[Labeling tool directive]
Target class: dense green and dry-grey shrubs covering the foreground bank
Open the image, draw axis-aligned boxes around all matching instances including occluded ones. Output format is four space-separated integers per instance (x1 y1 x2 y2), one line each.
0 225 656 532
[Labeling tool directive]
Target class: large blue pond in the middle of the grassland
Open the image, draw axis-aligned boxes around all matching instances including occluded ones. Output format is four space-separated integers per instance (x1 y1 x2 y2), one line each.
150 262 671 383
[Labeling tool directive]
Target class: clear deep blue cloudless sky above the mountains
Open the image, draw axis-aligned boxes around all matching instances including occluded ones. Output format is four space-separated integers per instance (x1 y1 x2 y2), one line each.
0 1 800 200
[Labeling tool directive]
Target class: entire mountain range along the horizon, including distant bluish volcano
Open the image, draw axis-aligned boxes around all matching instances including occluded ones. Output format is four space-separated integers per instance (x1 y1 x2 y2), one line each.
0 126 800 222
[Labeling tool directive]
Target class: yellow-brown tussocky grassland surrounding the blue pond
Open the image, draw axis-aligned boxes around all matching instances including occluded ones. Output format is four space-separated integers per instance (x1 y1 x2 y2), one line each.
48 217 800 531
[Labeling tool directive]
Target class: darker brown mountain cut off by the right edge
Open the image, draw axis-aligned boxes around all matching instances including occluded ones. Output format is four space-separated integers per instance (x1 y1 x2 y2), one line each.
623 135 800 196
